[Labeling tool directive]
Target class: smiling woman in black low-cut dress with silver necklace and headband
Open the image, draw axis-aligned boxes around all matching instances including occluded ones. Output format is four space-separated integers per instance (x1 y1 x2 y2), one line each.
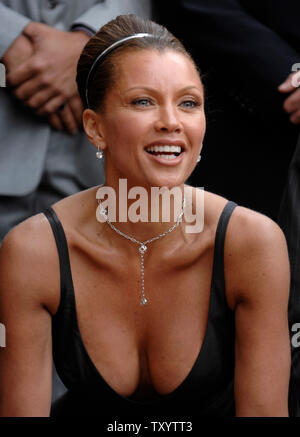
0 15 290 416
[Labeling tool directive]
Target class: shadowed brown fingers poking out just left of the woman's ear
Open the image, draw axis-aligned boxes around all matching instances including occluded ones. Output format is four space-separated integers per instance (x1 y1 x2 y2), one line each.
48 95 83 135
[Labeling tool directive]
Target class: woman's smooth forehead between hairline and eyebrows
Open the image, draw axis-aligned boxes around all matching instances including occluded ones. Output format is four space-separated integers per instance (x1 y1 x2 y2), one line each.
115 49 203 90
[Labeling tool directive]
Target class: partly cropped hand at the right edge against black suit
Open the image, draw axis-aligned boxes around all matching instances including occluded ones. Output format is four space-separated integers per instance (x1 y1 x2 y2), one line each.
278 71 300 124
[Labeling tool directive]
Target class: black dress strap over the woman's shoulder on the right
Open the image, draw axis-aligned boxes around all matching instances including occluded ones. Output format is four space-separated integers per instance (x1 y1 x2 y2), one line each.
213 200 238 303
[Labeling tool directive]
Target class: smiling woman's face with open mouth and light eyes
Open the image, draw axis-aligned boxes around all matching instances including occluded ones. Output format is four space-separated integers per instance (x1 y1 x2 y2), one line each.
98 50 205 188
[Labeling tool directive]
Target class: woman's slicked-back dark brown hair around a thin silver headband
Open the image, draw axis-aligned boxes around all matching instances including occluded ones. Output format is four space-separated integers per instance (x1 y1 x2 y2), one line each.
76 14 196 110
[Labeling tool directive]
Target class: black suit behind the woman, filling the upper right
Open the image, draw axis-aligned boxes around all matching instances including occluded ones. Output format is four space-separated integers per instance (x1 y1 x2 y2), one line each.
154 0 300 219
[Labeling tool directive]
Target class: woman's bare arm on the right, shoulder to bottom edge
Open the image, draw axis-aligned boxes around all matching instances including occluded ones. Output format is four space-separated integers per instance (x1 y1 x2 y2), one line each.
225 208 290 417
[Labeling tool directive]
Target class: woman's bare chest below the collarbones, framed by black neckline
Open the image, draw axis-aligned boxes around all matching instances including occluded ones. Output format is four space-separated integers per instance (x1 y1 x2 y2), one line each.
58 242 213 397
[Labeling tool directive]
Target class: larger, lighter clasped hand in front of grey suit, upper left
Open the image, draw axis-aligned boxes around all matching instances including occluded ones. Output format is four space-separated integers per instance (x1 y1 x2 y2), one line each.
7 22 89 115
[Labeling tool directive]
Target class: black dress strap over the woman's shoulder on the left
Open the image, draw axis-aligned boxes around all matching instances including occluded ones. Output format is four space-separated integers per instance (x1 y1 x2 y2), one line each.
43 207 73 309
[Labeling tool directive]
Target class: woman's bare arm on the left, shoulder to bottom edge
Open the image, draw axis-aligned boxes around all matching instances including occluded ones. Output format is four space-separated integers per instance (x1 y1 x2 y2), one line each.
0 219 52 417
